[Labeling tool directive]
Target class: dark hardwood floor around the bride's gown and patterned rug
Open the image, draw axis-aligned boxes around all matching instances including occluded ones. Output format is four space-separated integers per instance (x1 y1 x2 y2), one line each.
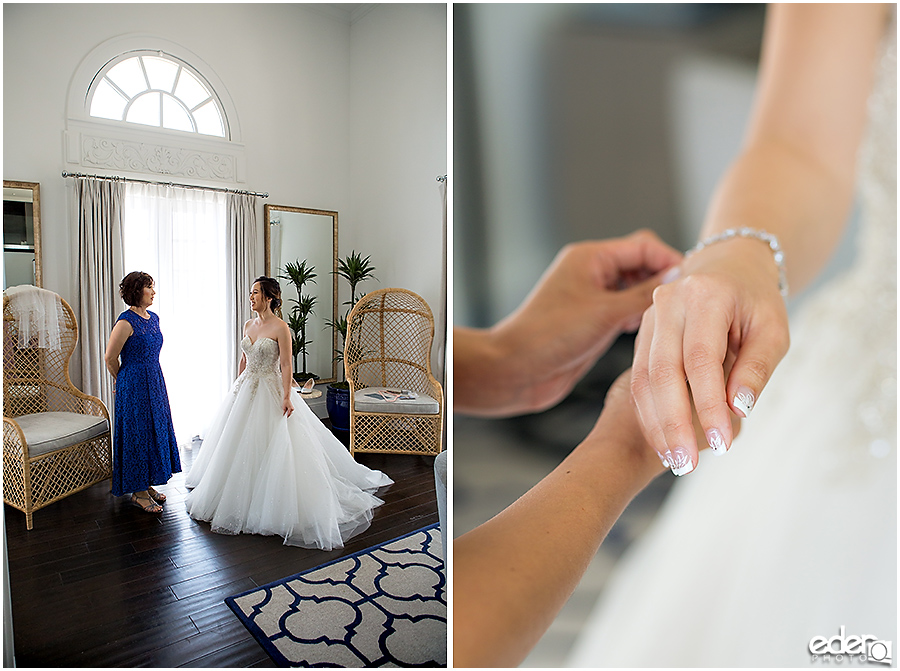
4 440 438 668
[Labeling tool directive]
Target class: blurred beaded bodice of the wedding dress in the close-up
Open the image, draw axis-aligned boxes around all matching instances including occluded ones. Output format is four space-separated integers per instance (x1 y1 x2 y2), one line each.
792 11 897 476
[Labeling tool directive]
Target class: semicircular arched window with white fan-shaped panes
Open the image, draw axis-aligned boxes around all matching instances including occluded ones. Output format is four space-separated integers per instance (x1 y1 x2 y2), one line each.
88 51 229 139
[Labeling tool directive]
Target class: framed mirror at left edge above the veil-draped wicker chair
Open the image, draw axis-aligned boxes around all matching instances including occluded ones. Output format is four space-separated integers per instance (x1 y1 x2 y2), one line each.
3 180 42 290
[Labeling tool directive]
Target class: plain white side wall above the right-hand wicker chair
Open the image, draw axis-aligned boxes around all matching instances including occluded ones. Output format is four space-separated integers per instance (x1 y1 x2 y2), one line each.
348 4 447 373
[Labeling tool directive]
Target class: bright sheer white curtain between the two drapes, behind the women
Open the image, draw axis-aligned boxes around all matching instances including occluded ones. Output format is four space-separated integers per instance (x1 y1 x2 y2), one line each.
123 183 230 444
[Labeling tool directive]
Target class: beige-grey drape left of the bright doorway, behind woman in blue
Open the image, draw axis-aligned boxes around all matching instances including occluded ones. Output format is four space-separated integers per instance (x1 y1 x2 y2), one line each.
75 177 125 414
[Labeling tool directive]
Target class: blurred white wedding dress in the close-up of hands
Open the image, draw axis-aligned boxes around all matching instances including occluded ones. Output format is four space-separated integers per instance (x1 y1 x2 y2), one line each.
568 15 897 668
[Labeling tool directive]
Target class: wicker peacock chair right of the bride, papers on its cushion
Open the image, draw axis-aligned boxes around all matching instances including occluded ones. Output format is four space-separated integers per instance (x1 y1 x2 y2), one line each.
344 289 444 454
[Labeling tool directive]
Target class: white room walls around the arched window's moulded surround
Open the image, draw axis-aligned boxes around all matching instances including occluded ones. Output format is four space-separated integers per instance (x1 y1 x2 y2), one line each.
3 3 447 384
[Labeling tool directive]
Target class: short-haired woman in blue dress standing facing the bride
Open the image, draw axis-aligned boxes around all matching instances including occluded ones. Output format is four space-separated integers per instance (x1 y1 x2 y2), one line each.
105 271 181 513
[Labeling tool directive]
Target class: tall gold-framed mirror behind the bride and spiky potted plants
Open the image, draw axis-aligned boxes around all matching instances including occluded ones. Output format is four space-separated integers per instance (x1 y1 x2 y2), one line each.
265 204 338 382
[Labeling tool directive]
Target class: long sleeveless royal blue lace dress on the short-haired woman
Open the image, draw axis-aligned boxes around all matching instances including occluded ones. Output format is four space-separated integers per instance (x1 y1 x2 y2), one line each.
112 310 181 496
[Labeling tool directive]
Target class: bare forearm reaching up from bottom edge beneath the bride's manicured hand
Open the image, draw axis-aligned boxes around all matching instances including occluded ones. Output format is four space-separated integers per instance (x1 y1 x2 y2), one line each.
453 415 662 667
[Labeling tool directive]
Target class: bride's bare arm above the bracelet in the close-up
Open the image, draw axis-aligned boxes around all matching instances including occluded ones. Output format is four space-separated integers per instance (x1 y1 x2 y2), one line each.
704 3 889 290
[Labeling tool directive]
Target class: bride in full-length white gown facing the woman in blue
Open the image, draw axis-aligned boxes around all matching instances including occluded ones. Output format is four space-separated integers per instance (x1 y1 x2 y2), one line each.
186 277 393 550
